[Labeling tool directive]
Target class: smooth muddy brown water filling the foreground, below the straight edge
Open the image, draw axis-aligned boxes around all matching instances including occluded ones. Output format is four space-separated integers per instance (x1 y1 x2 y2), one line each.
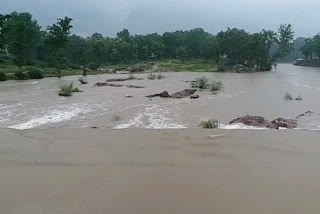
0 128 320 214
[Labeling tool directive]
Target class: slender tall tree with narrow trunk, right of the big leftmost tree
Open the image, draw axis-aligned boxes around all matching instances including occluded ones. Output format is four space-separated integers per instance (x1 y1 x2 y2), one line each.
47 17 72 78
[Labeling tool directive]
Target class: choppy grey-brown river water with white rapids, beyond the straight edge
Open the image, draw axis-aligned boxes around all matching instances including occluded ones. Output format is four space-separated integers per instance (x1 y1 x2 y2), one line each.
0 64 320 130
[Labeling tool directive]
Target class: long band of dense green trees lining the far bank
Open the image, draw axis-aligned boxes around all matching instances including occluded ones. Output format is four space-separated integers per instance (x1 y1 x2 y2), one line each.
0 12 294 77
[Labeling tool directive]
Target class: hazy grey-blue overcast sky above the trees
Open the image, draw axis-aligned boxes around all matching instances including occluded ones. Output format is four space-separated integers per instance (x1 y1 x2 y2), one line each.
0 0 320 37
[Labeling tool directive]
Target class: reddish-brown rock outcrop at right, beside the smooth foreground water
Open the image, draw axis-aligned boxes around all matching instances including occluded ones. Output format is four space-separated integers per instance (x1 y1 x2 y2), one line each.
230 115 298 129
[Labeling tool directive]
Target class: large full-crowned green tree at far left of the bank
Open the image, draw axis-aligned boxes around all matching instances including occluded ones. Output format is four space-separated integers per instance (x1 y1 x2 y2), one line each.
3 12 40 69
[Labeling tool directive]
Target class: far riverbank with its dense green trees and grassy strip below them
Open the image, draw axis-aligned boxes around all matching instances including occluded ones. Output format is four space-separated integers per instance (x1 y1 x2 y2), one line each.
0 12 296 81
